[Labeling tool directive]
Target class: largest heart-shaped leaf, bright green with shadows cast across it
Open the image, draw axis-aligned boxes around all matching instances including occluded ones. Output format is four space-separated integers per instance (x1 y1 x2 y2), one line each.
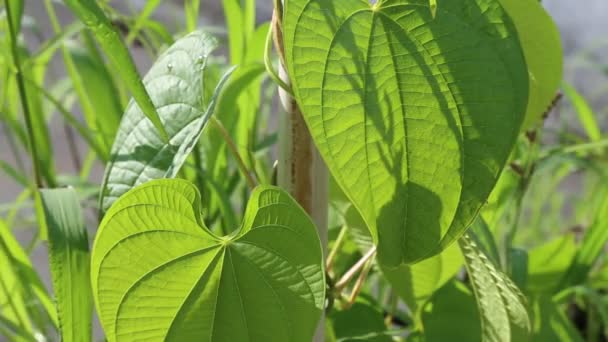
283 0 528 266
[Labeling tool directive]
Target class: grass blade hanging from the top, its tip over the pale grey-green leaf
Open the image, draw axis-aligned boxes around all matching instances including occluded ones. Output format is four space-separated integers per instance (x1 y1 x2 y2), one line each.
63 0 168 140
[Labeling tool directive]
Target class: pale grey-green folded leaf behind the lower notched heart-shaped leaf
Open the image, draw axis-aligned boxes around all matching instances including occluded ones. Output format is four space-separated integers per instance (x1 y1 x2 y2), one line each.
101 31 233 211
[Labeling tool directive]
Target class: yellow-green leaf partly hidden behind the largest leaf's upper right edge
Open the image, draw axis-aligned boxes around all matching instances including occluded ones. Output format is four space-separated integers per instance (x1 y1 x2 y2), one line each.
499 0 563 129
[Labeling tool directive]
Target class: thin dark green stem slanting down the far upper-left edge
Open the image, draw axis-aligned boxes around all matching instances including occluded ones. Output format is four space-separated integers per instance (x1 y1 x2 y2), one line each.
4 0 43 188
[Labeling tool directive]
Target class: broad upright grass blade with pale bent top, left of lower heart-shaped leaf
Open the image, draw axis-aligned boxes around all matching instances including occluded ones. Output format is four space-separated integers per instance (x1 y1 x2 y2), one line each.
40 188 93 342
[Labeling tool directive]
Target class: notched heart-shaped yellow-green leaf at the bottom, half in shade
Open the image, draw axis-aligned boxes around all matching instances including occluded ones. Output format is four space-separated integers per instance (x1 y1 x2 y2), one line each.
92 179 325 341
